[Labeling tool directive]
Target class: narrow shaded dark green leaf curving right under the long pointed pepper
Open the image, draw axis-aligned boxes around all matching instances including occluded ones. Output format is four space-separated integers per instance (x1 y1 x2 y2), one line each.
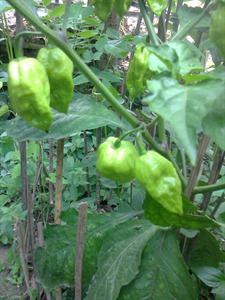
143 193 220 229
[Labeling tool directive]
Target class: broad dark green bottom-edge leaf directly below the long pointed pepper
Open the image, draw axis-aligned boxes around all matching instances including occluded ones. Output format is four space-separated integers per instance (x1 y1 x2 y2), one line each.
118 230 198 300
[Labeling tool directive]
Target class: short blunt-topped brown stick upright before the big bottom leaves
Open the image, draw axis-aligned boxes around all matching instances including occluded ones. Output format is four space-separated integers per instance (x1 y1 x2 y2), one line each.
74 202 88 300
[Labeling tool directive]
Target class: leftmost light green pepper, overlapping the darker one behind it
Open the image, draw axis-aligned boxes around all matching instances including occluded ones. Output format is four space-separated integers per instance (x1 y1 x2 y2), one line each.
8 57 52 131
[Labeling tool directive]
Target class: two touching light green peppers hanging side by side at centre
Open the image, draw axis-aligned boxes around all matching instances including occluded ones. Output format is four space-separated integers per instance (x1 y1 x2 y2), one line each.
96 137 183 214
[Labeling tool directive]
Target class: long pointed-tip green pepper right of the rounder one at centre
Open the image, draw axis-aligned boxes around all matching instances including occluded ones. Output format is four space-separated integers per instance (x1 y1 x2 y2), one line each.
135 151 183 214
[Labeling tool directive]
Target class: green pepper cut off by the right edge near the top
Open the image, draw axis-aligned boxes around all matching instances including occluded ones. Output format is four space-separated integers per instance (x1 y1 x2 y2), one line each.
209 4 225 59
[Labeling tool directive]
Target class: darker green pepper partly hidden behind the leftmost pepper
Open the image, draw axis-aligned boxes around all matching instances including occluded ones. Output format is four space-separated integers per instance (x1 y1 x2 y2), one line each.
37 48 73 113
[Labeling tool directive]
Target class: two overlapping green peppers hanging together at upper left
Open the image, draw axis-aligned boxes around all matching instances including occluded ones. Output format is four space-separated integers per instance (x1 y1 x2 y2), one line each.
8 48 73 131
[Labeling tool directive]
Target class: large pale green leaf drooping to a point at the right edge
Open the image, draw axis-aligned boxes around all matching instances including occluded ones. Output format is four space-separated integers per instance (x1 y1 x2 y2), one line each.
143 77 225 164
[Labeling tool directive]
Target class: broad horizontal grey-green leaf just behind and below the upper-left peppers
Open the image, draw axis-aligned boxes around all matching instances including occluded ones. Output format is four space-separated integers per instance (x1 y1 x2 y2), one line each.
0 95 126 141
